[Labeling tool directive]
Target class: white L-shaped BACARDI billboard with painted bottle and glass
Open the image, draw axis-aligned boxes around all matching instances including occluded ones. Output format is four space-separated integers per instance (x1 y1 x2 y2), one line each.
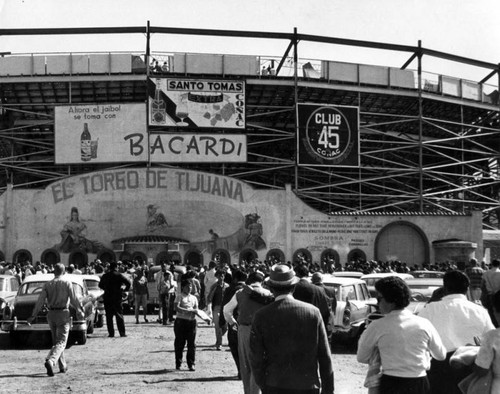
55 104 247 164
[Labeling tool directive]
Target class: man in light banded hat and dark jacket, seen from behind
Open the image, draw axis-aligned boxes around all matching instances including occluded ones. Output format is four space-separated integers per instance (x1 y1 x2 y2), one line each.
250 264 334 394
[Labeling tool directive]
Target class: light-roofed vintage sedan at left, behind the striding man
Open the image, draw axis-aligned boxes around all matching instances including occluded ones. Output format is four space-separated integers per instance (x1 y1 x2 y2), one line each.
1 274 95 345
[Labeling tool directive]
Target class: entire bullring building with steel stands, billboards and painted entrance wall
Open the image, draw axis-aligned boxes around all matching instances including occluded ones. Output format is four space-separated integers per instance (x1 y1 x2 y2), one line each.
0 23 500 266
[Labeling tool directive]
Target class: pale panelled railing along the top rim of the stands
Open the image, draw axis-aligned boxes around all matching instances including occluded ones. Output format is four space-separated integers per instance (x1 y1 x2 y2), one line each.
0 52 498 104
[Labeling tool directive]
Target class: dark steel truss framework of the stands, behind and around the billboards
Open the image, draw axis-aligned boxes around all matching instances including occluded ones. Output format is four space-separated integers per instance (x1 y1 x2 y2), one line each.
0 24 500 229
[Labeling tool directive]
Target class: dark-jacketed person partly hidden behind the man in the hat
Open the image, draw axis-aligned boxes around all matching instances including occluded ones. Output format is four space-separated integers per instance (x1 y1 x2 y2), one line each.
293 264 331 327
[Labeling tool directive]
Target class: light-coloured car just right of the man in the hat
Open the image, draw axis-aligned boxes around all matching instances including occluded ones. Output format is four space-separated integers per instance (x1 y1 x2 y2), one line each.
323 275 377 344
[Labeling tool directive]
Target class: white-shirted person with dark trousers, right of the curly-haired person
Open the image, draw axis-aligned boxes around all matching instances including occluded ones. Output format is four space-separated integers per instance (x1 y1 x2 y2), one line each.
419 271 495 394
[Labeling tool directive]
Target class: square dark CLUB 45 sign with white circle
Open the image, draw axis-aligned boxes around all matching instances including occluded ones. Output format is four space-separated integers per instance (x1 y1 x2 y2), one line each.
297 104 359 167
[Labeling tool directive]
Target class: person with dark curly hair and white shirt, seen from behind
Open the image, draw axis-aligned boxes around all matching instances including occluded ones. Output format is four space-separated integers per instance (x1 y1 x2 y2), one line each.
357 276 446 394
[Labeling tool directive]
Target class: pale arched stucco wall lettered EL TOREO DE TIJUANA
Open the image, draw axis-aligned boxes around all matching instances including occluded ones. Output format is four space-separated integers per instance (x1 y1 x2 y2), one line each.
0 168 482 263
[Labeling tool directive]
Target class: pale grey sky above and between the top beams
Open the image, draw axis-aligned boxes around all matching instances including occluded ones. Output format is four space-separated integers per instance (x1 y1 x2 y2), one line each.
0 0 500 83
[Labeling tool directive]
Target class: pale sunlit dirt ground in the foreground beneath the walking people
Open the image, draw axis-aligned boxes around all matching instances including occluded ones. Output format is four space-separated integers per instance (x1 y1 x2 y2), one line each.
0 315 366 394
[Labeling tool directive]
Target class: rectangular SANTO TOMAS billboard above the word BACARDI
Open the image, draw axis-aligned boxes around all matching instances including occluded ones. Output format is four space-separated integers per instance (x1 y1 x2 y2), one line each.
148 78 245 129
